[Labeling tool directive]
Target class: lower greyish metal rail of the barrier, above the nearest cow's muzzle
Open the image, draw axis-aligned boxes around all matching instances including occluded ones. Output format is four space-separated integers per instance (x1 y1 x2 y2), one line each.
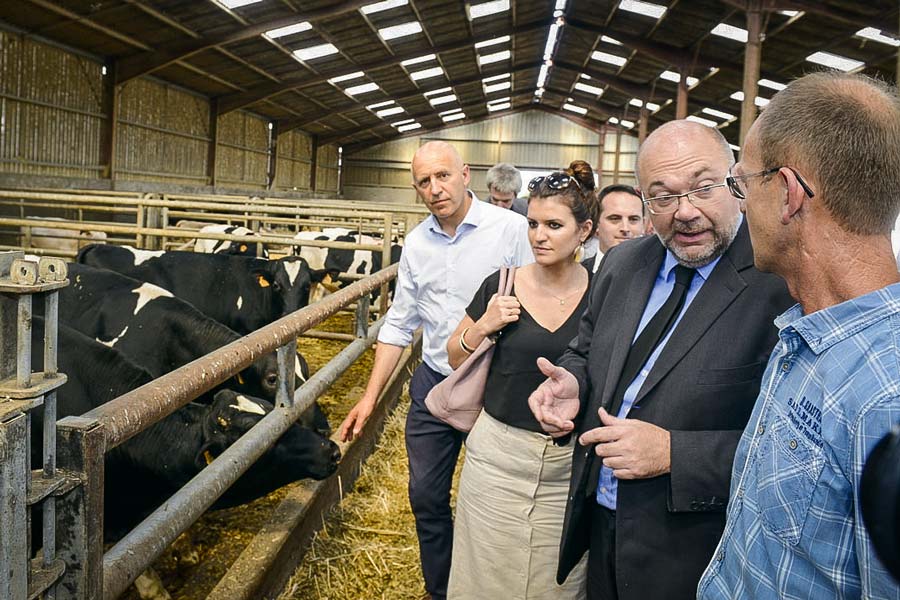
103 320 383 600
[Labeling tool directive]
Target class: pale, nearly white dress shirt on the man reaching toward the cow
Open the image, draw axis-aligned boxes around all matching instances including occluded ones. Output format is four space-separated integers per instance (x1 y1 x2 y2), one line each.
378 195 534 375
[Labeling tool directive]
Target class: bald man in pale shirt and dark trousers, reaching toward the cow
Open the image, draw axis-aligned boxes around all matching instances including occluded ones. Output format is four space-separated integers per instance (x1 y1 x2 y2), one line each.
340 141 534 600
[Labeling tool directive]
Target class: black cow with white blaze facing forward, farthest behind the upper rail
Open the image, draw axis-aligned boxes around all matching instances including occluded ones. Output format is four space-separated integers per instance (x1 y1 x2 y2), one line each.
77 245 315 334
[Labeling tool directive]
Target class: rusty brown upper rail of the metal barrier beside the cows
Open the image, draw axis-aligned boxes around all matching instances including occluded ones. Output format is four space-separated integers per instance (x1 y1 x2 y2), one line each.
83 264 398 451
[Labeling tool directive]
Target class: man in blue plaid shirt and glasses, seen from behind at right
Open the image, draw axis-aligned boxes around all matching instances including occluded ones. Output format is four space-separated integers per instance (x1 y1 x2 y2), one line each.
698 73 900 600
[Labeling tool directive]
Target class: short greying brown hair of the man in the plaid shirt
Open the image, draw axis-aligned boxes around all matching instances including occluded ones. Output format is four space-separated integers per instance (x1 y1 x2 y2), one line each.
756 71 900 235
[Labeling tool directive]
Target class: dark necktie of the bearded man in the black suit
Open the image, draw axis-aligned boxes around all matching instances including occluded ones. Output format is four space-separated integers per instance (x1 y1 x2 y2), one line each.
585 265 697 496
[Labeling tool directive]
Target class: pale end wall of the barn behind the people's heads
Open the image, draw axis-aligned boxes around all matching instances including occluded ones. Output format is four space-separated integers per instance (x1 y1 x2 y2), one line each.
344 111 637 203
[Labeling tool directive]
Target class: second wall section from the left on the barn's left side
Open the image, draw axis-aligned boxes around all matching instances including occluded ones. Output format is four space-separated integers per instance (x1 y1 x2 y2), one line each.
115 79 210 185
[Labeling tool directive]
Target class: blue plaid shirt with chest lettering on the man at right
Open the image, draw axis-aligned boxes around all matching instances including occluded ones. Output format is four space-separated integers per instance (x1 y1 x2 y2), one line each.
697 283 900 600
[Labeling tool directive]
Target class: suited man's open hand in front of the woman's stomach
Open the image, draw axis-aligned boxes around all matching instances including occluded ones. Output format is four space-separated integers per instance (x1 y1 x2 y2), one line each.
528 357 580 437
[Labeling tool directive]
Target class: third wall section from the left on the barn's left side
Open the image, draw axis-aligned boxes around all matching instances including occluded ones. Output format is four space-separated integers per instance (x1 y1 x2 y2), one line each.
216 111 270 188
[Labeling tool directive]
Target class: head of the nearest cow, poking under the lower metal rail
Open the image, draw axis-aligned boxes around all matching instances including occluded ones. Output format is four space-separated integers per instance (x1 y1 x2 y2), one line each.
196 390 341 508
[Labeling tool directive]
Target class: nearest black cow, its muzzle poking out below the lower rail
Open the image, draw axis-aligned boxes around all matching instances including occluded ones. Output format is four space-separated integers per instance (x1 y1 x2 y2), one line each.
31 317 340 540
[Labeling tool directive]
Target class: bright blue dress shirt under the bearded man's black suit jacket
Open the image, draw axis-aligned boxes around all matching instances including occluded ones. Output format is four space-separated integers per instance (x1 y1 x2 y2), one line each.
597 250 722 510
